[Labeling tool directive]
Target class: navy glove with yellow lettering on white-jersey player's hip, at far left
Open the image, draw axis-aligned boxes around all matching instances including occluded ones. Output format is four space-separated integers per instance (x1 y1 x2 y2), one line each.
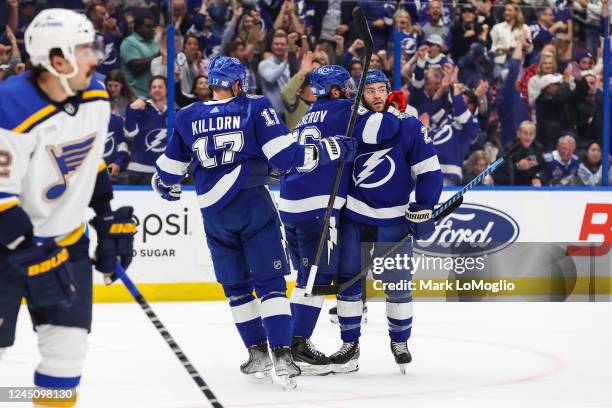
8 239 76 307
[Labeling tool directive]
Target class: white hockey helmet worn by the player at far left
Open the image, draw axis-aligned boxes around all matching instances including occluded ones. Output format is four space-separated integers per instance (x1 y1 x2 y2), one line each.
24 8 96 95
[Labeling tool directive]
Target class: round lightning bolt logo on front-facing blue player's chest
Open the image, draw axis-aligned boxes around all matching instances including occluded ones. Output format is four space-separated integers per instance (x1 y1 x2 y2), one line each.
353 148 395 188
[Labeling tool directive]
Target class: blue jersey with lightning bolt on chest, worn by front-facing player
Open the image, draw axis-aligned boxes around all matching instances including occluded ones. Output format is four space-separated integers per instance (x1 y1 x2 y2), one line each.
345 116 442 226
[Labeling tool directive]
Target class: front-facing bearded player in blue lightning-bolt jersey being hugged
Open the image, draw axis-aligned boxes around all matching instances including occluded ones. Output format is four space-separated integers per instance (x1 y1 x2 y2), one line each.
332 70 442 373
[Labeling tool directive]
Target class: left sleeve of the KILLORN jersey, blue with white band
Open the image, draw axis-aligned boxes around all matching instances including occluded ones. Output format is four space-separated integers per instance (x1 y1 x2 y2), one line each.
155 126 192 186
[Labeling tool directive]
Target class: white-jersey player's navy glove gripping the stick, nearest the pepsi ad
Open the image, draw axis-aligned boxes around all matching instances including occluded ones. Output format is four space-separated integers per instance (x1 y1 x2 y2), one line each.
90 207 136 285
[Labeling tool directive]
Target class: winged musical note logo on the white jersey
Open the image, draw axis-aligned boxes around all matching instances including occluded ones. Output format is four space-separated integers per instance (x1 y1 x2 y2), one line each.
43 133 96 200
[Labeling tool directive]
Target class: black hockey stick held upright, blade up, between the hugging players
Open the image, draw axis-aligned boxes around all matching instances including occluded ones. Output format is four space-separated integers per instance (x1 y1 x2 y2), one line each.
305 7 374 296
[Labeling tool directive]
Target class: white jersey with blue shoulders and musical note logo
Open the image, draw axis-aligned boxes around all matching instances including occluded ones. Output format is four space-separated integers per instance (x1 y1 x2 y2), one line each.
0 73 110 239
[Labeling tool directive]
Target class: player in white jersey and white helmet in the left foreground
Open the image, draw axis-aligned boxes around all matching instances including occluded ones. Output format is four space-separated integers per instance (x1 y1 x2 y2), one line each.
0 9 135 406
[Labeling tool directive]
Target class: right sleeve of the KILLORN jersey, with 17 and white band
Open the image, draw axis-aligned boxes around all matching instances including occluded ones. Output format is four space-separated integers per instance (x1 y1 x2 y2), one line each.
251 97 306 171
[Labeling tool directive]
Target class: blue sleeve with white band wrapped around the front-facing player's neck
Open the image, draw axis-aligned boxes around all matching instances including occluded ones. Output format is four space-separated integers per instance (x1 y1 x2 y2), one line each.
352 107 400 144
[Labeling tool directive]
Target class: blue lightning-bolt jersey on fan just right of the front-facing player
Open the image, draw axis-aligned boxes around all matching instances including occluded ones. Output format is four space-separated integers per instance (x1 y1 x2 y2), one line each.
431 95 479 186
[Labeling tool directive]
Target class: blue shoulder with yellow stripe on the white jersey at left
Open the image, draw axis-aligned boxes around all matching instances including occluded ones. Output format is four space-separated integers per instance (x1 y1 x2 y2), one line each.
0 73 58 133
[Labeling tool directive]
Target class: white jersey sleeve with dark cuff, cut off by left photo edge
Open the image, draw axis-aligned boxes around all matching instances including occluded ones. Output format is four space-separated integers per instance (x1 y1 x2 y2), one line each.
0 128 36 249
